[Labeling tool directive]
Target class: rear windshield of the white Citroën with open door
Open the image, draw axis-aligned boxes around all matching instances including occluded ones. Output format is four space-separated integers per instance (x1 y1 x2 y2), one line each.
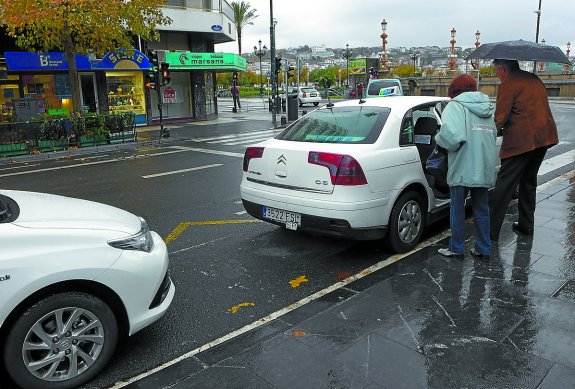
276 105 390 143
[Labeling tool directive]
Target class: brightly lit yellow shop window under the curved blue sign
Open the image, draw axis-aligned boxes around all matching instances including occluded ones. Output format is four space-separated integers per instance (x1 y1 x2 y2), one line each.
106 71 146 115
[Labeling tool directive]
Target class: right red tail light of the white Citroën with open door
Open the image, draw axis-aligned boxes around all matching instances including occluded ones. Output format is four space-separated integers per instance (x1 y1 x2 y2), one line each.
307 151 367 186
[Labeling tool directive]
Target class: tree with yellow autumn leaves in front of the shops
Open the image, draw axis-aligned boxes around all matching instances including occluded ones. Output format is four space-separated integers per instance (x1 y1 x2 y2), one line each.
0 0 171 112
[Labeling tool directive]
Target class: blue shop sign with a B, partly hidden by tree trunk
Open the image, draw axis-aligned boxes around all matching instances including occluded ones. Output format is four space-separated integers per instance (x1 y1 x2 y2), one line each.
5 51 90 71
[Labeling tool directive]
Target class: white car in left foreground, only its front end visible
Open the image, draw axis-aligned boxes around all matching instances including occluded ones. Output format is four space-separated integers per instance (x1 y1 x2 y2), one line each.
0 190 175 389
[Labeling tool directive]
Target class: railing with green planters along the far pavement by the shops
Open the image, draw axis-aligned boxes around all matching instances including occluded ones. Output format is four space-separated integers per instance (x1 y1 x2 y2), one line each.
0 113 137 157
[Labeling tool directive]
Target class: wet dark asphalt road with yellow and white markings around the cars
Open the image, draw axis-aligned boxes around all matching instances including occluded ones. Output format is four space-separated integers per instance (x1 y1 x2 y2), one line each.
0 101 575 387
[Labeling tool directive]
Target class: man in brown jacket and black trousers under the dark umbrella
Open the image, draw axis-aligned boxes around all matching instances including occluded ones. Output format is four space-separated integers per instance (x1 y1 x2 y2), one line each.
490 59 559 241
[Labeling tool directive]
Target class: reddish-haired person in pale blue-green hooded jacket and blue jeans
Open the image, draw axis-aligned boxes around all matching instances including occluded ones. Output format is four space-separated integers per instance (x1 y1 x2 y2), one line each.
435 74 497 261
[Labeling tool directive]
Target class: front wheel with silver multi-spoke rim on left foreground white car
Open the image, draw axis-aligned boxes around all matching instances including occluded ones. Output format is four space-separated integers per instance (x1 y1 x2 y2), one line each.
3 292 118 389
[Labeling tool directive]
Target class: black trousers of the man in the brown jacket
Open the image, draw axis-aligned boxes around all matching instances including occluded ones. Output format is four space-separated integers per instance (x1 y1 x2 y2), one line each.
489 147 547 238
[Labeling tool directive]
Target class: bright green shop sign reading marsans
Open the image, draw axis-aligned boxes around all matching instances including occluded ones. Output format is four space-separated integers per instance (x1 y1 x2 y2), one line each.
166 51 247 72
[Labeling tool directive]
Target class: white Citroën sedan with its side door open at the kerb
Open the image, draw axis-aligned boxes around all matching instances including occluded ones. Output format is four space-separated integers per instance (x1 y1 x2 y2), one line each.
241 96 500 252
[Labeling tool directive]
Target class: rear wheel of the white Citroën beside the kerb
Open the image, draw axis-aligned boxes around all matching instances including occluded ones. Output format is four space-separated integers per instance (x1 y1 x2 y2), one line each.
387 192 425 253
